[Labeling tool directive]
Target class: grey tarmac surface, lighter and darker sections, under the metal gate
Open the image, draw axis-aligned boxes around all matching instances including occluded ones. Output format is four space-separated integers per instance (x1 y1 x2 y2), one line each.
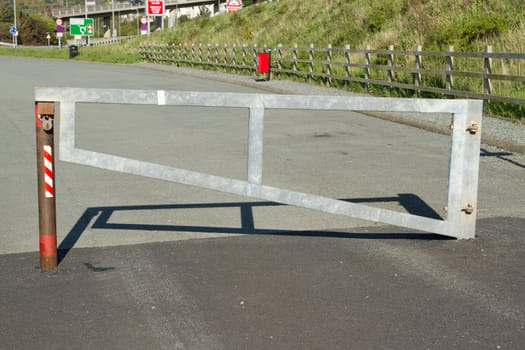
0 56 525 349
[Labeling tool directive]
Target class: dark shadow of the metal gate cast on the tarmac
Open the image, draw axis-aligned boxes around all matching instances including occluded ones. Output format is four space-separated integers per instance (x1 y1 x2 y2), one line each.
58 193 453 263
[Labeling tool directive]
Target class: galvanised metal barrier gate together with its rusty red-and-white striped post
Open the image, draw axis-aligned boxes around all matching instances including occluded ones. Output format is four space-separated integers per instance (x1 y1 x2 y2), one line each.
35 87 482 269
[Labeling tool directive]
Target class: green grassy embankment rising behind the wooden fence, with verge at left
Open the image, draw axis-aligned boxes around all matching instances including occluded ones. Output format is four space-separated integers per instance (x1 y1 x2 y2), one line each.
0 0 525 120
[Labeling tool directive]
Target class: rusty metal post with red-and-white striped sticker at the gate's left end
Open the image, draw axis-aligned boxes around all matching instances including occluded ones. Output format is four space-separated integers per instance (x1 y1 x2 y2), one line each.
35 102 58 270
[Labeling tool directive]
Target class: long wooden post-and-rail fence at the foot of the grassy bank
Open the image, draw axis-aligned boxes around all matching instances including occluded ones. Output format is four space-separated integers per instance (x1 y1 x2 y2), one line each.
139 44 525 105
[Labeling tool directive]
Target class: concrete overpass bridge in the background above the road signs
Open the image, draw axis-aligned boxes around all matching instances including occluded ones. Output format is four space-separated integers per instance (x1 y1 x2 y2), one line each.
51 0 227 22
